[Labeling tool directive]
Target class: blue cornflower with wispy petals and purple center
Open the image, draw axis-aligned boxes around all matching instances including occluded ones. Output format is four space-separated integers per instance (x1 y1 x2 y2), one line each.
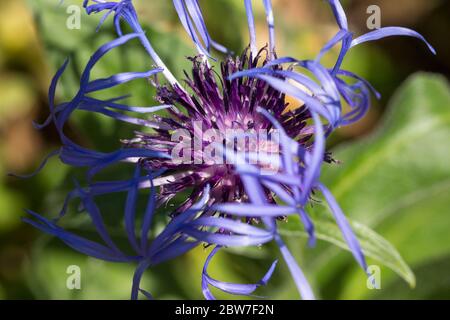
19 0 434 299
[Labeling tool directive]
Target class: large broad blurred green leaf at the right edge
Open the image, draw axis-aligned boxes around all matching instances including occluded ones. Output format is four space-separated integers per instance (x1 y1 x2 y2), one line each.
310 73 450 298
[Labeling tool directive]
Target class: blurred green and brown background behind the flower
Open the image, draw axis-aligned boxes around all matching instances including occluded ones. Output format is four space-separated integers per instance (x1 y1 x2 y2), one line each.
0 0 450 299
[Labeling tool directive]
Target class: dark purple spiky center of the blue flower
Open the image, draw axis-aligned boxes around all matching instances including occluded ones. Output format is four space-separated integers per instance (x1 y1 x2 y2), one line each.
123 49 311 211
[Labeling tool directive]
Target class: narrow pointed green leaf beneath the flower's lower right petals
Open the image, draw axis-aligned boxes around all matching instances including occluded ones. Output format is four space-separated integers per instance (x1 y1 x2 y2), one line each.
279 206 416 287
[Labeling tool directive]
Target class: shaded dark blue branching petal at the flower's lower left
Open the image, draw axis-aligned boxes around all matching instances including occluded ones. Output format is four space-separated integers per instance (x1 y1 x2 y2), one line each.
23 172 213 299
